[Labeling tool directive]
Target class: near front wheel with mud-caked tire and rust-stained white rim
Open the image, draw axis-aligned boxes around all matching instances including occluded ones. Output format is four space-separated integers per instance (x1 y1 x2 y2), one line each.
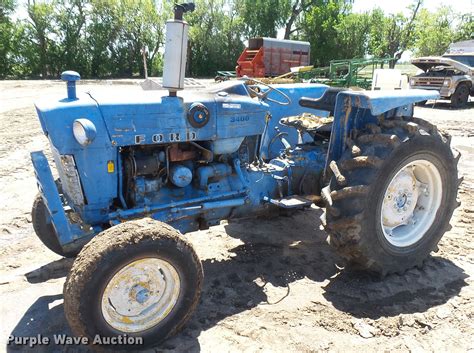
64 219 203 349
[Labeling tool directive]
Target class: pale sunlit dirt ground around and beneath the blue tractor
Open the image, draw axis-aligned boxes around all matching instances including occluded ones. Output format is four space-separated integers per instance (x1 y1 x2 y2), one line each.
0 81 474 352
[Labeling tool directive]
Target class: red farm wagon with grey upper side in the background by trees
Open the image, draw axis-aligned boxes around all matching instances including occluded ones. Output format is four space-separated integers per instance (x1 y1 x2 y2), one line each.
236 37 310 77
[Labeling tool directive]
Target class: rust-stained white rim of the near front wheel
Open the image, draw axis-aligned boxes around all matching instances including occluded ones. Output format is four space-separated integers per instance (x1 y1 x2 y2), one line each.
101 258 180 332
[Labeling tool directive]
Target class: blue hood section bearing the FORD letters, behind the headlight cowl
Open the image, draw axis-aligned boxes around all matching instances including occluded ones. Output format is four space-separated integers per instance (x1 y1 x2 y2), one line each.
93 92 216 146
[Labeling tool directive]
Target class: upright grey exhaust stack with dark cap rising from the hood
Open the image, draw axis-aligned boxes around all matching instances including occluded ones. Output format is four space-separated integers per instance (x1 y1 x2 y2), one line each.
163 3 195 97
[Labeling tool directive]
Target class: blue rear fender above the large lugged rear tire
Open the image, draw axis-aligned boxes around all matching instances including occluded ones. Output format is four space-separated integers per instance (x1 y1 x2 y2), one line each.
326 89 439 168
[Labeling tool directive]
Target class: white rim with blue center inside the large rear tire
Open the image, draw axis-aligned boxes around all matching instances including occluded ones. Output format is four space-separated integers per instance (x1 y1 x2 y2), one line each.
380 160 442 247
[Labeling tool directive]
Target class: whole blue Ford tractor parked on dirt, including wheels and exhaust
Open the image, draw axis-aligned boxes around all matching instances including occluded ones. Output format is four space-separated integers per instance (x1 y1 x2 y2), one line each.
31 4 459 349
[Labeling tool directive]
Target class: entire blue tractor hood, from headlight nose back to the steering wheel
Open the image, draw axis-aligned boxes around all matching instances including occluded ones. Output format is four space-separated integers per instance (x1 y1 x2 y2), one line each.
36 83 269 153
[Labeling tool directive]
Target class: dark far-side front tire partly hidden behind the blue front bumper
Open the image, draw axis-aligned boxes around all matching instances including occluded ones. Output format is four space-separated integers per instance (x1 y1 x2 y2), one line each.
31 194 78 257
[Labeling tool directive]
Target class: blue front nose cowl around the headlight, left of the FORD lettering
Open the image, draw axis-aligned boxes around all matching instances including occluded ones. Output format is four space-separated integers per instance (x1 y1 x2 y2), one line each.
37 95 117 223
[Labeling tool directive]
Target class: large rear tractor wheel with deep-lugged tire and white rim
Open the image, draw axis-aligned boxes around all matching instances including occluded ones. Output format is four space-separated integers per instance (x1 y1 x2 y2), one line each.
323 118 459 274
